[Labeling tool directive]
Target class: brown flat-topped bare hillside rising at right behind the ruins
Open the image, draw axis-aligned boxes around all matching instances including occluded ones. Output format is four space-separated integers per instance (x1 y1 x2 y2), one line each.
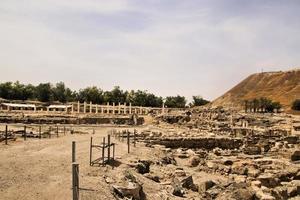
213 69 300 110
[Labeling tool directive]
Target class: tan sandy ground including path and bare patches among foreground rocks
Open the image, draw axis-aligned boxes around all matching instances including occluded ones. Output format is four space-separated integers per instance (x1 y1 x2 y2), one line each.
0 125 227 200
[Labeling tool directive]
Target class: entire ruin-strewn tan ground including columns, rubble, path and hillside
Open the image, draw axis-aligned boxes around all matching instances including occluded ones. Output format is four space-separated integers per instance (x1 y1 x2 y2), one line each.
0 70 300 200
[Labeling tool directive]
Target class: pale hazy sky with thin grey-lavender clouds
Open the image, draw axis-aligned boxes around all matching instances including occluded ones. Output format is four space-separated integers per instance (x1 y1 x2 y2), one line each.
0 0 300 99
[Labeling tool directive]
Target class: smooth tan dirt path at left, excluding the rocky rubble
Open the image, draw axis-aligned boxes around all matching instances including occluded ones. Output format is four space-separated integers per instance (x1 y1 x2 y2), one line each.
0 126 150 200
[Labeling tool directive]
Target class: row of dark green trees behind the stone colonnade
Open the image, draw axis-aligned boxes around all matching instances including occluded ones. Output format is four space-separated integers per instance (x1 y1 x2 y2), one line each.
0 81 209 108
